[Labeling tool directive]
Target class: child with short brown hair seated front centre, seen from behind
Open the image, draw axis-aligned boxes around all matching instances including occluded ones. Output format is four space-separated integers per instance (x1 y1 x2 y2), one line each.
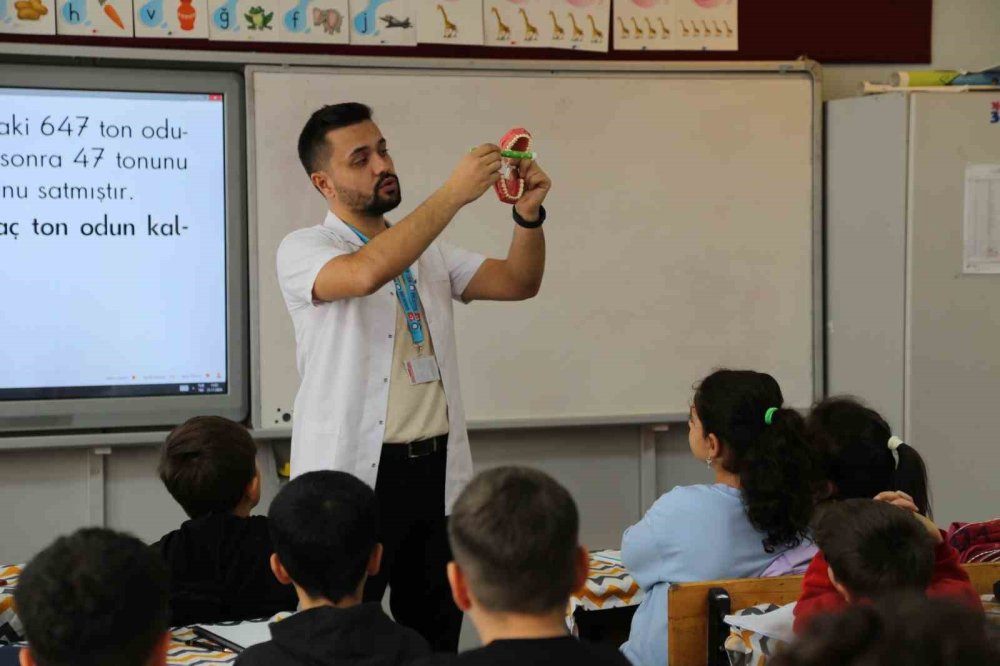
418 467 628 666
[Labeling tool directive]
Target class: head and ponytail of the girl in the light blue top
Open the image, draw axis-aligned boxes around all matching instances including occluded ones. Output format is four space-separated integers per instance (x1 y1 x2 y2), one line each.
688 370 821 552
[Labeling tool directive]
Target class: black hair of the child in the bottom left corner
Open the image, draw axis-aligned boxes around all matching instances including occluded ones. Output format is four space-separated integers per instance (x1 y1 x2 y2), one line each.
14 528 168 666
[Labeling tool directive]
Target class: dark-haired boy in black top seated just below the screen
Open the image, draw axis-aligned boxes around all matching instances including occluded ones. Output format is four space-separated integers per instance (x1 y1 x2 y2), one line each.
153 416 297 626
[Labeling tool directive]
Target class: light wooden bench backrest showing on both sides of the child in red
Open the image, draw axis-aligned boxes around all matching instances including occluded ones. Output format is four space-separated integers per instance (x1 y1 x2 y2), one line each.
667 562 1000 666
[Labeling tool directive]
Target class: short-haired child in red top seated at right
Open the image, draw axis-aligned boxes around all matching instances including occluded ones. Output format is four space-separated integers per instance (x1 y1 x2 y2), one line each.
795 499 982 632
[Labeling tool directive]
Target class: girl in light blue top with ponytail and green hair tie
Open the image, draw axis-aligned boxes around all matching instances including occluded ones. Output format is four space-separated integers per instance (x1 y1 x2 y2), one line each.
622 370 821 666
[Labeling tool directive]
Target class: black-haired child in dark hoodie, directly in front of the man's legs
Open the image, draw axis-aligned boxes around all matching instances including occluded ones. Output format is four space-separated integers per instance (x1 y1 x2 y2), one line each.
236 471 430 666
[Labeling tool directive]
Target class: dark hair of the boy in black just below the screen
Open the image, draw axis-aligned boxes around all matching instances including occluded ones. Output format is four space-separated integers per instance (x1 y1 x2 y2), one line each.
159 416 257 518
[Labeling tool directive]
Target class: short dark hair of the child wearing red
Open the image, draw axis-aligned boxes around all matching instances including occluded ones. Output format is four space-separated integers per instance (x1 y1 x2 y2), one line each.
813 499 934 598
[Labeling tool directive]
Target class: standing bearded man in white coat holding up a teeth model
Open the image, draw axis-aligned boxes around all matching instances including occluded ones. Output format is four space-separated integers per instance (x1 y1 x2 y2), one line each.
278 103 551 652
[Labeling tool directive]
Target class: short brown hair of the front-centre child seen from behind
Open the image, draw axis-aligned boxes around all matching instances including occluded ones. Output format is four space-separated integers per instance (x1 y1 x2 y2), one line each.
448 467 580 614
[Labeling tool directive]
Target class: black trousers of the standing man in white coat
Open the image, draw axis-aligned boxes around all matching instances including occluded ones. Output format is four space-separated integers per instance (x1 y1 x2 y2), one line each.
364 444 462 653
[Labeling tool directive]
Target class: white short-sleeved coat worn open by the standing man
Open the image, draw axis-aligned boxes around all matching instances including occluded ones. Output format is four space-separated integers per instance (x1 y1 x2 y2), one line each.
278 213 485 513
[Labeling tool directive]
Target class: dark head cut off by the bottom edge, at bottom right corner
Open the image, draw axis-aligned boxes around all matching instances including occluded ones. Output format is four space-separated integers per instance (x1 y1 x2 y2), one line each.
770 593 1000 666
